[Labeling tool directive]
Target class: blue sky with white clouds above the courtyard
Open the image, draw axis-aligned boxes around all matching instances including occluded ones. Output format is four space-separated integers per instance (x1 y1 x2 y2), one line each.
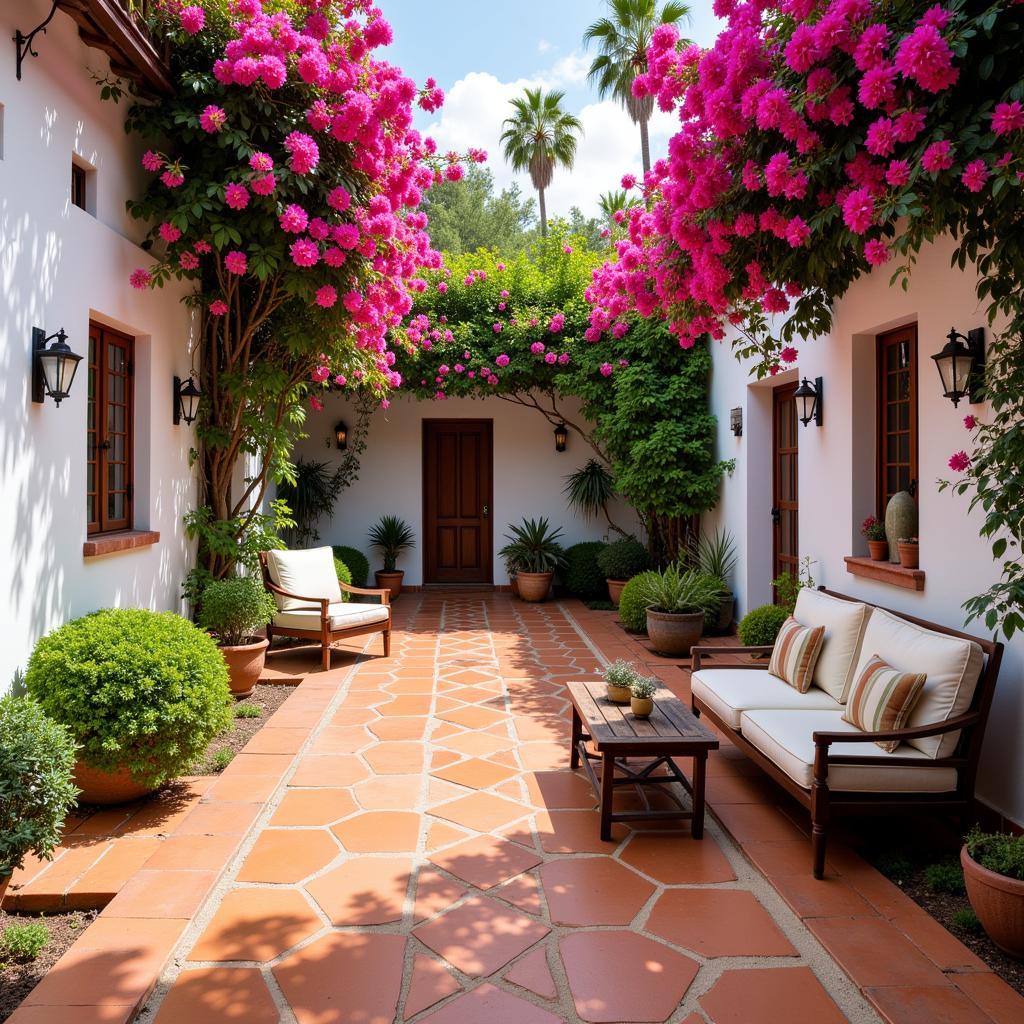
379 0 718 215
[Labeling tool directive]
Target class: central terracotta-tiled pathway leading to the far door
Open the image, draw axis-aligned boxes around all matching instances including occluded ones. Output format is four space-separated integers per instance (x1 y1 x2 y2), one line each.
140 594 880 1024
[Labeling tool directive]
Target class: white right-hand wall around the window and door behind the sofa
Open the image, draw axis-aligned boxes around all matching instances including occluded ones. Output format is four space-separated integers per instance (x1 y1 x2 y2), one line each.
705 235 1024 822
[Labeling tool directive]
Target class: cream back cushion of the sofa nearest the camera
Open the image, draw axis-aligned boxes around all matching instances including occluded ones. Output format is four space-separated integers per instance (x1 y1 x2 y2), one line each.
856 608 985 758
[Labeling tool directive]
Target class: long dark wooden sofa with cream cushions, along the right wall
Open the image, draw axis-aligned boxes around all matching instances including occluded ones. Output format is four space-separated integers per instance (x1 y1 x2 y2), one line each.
691 587 1002 879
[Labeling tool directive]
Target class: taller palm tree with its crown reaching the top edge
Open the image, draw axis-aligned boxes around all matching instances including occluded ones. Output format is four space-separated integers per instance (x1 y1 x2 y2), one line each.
583 0 690 174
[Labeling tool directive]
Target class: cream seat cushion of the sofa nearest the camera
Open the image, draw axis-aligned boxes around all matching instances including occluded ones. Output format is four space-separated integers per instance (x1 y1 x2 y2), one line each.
740 710 956 793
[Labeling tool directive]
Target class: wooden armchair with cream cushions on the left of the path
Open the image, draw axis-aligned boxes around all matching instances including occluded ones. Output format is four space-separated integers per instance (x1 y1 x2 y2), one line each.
259 548 391 671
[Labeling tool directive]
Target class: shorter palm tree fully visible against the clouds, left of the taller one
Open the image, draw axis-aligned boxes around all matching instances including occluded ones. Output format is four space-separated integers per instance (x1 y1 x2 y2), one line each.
502 88 583 236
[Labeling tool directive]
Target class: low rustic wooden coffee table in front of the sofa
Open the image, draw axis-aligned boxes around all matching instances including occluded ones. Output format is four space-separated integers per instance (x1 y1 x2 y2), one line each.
568 682 718 840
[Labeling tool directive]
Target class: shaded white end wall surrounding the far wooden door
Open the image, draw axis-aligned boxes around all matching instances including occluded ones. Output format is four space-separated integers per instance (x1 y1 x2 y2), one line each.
296 395 639 586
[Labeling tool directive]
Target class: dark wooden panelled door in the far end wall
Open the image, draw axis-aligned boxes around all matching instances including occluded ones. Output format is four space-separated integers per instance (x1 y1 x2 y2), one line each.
423 420 494 584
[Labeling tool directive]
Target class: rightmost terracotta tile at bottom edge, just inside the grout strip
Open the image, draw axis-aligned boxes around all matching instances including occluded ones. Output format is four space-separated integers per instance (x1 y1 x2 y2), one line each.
698 967 846 1024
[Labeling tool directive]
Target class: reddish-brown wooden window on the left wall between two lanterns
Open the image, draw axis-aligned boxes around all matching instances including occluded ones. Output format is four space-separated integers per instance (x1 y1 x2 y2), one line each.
86 321 135 537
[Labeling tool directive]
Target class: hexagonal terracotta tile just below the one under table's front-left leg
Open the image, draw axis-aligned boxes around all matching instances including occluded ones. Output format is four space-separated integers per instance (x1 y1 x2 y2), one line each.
540 857 654 926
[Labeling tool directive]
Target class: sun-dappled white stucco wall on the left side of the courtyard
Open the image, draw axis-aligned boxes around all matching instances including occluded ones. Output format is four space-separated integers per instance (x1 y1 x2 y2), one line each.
0 0 195 693
